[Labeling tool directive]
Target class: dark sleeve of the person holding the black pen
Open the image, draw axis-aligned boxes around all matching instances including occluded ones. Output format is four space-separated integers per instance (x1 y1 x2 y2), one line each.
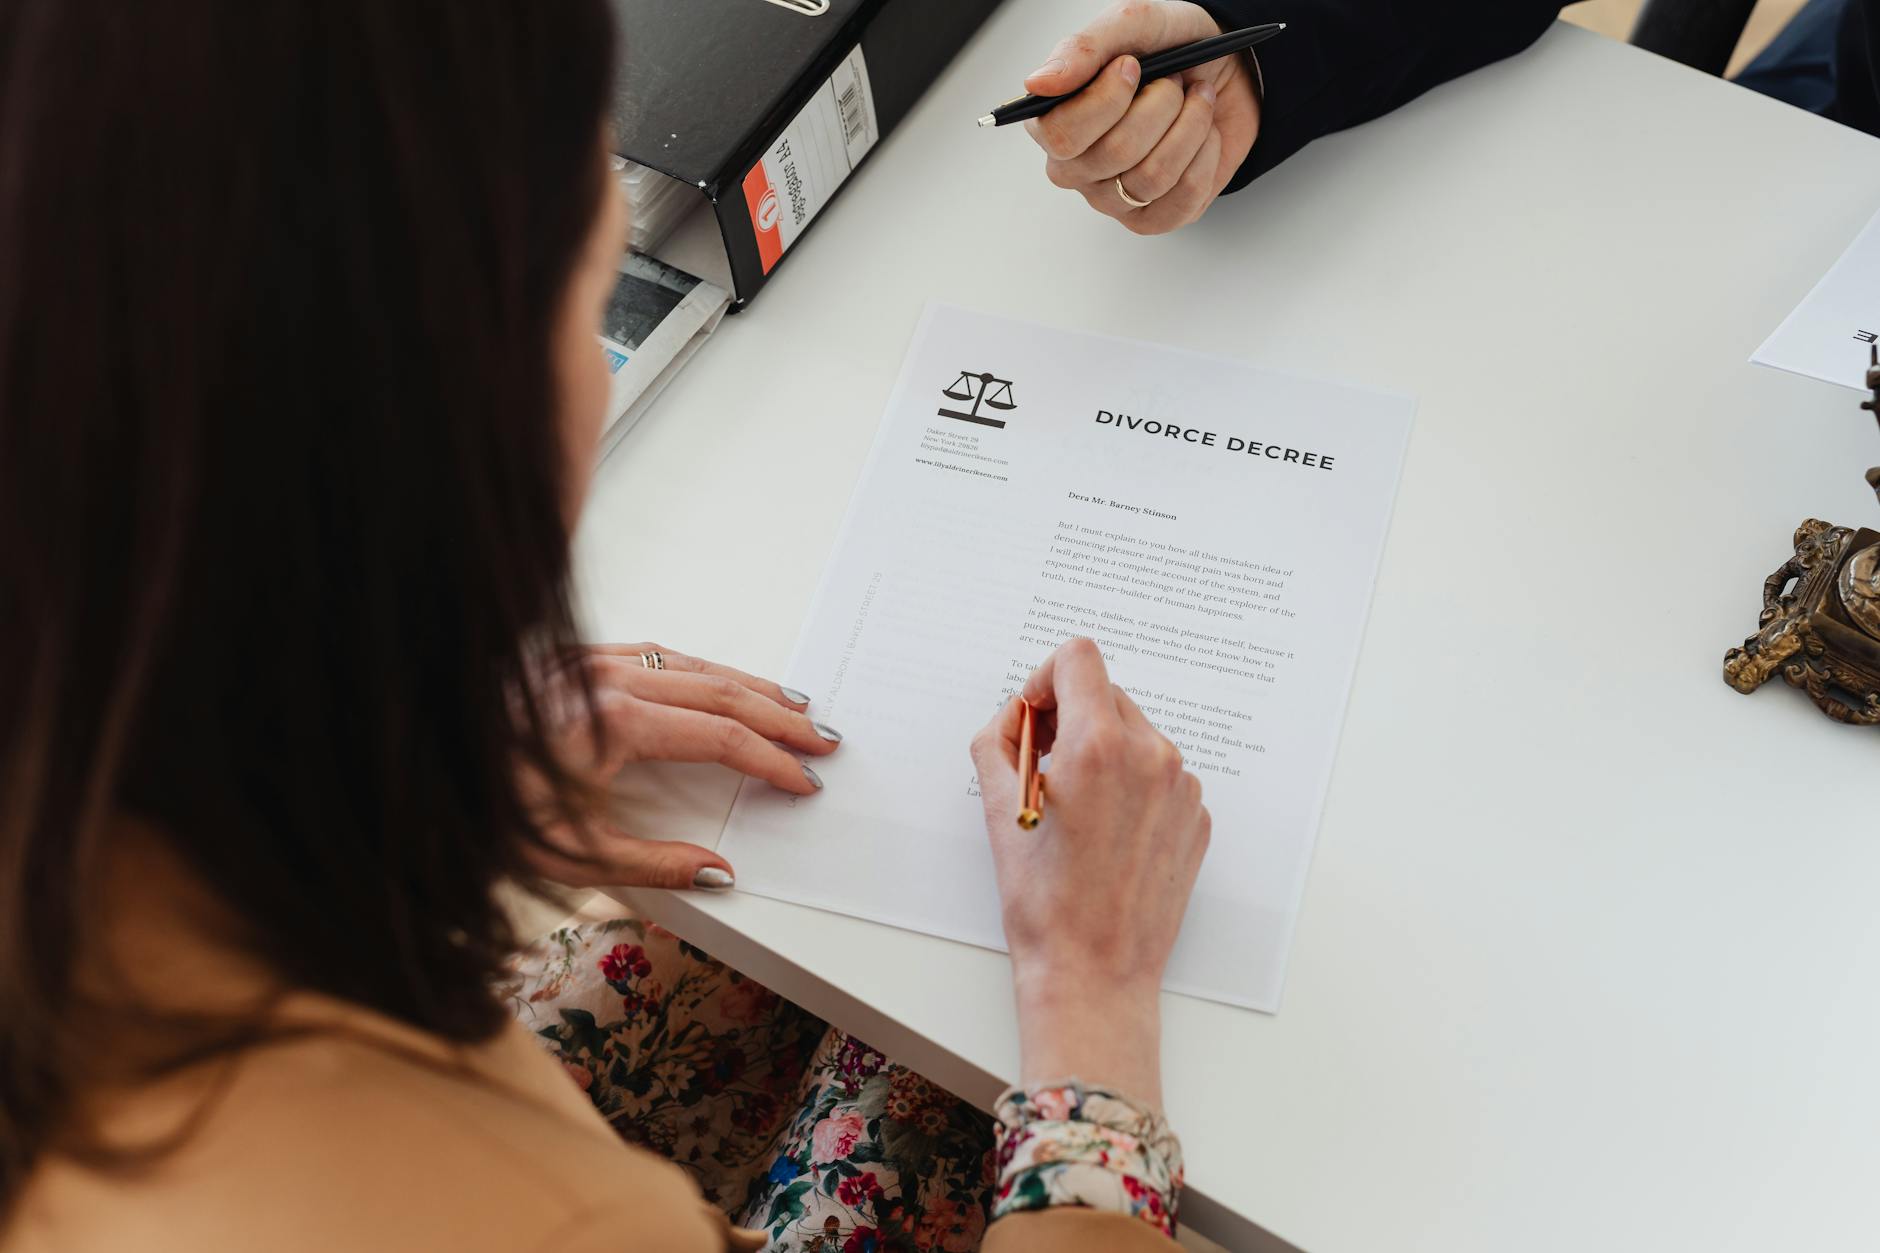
1199 0 1560 192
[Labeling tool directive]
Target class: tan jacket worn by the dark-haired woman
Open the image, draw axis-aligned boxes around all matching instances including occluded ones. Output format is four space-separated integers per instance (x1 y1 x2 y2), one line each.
0 835 1173 1253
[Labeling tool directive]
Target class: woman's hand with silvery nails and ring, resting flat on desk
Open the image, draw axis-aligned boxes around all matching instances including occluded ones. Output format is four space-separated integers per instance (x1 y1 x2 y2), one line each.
528 643 842 888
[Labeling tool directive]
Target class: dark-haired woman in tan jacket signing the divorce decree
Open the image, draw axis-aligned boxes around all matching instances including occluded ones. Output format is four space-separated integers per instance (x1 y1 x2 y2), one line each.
0 0 1207 1253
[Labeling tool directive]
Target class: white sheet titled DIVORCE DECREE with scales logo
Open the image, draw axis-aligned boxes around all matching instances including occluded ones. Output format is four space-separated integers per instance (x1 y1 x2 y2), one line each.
718 307 1414 1010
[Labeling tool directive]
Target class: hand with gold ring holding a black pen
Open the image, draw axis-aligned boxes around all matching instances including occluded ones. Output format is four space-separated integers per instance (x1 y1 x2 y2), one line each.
1025 0 1260 235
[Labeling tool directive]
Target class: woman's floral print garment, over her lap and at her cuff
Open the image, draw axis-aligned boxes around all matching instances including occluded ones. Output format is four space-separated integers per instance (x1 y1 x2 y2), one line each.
502 918 1181 1253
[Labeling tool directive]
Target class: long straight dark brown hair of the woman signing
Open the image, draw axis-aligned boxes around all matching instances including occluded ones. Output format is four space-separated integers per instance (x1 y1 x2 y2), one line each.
0 0 613 1215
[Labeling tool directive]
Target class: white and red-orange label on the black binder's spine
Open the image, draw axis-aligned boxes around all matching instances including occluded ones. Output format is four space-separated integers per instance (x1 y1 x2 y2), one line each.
744 45 882 273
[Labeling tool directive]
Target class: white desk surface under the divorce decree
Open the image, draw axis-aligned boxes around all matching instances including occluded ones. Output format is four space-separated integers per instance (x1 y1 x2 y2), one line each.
577 12 1880 1253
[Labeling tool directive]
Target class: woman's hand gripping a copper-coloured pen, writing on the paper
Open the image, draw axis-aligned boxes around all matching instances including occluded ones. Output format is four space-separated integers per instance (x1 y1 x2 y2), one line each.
972 640 1211 1104
